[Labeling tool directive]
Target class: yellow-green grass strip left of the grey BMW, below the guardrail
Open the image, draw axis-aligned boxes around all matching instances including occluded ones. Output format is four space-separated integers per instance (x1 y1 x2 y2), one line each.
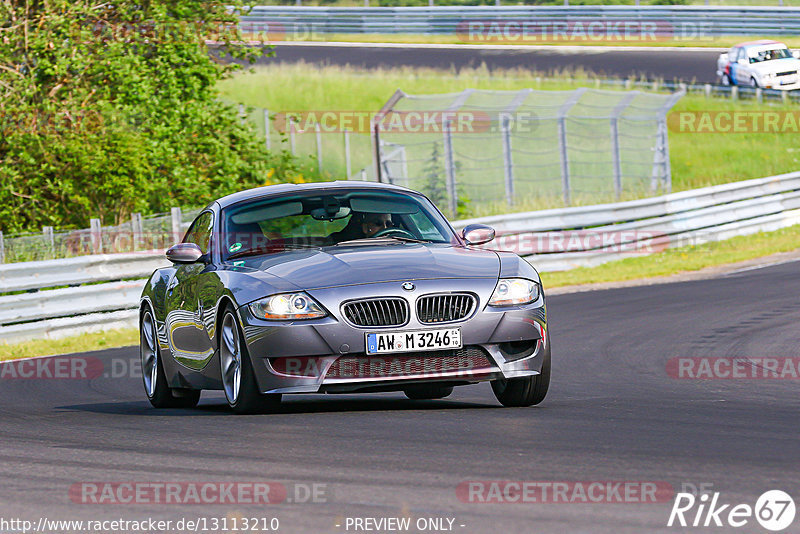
0 328 139 361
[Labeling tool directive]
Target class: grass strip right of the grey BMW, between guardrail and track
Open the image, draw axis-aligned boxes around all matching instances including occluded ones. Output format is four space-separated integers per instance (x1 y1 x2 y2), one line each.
541 225 800 288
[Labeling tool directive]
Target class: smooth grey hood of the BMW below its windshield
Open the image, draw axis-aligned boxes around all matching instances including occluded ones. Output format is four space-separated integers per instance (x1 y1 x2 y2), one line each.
247 243 500 289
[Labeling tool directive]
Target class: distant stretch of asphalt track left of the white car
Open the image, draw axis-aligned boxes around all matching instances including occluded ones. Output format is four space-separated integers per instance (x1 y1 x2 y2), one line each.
259 43 720 83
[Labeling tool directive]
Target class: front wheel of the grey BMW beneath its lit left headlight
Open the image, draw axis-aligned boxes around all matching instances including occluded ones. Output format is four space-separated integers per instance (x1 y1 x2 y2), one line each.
219 307 281 414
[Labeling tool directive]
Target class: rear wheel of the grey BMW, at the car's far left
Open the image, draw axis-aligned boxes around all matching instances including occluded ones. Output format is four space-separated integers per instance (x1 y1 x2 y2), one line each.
139 309 201 408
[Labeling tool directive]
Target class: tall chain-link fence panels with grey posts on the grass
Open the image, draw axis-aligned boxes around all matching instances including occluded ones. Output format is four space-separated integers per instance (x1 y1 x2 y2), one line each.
374 88 683 214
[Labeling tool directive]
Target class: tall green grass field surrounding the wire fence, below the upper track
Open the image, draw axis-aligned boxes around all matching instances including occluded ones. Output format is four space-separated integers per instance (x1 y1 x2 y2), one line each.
219 64 800 201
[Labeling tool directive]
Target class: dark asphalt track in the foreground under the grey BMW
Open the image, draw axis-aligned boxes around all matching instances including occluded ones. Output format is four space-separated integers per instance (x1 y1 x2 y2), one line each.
0 263 800 533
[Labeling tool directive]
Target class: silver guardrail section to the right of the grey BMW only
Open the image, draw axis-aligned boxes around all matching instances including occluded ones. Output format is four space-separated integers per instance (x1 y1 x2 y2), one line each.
455 172 800 271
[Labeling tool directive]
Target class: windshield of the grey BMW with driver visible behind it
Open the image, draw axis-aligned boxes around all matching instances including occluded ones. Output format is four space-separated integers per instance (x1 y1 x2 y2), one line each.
222 189 454 260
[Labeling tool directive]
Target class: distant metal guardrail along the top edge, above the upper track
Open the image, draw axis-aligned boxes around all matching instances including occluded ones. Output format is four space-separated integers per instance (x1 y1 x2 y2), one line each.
241 6 800 36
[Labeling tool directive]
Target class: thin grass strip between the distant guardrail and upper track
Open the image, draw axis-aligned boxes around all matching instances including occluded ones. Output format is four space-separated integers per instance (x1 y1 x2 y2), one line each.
266 33 800 48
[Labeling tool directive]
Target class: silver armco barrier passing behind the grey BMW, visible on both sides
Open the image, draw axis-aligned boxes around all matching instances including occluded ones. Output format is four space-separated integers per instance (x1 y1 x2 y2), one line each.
0 172 800 342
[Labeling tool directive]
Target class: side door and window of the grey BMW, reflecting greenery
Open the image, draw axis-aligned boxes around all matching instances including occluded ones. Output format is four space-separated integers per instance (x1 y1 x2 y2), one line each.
167 211 214 370
